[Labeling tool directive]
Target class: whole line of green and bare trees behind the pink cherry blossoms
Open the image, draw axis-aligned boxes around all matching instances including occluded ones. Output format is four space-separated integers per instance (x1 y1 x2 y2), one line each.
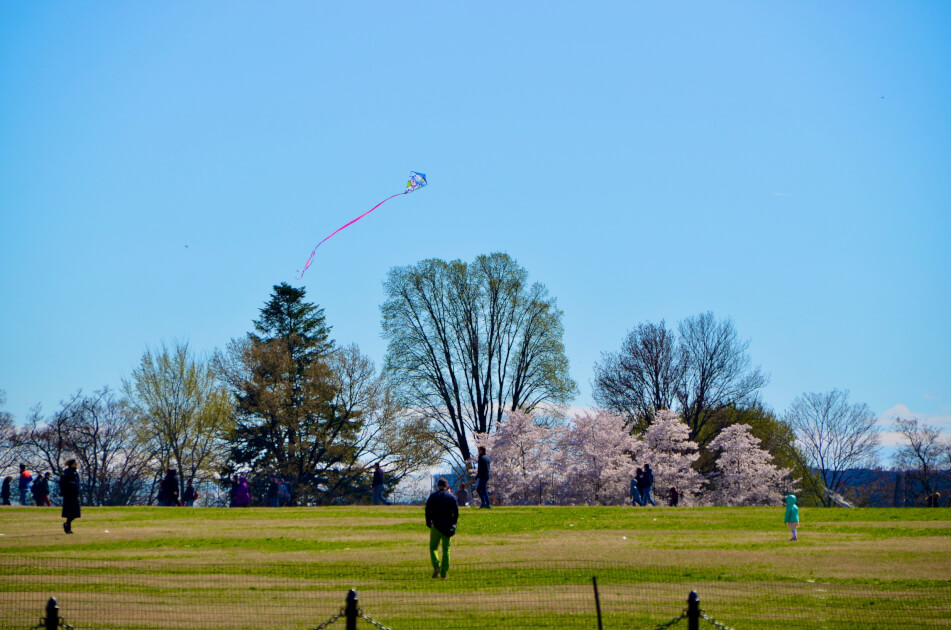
0 253 951 505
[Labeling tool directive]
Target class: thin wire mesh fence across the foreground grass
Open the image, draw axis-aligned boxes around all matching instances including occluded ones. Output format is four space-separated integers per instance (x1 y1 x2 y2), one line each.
0 550 951 630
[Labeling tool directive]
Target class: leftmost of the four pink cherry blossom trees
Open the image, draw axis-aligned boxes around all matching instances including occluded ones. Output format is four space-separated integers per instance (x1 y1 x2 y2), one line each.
475 411 561 505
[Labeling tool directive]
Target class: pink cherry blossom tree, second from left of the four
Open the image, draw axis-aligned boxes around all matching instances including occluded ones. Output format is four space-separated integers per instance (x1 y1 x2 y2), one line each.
555 411 637 505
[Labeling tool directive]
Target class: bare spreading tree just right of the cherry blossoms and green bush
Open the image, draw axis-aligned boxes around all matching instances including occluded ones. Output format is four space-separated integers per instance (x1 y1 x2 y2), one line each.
784 389 879 507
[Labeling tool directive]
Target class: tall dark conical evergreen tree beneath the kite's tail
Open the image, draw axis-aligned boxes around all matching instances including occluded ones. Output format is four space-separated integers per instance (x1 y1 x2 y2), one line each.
218 283 363 503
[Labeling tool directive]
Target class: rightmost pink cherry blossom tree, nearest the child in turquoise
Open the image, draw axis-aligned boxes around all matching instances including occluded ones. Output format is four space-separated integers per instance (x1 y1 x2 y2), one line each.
705 424 793 505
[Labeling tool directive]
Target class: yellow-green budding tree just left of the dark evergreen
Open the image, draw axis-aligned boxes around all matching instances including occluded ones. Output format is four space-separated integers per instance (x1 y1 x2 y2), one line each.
123 344 232 502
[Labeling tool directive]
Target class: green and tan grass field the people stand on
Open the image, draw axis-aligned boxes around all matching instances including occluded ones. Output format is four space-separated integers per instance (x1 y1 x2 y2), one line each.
0 506 951 630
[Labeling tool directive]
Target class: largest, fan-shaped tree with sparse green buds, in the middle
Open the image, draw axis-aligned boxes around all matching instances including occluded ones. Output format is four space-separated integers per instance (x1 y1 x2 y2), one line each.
382 253 576 470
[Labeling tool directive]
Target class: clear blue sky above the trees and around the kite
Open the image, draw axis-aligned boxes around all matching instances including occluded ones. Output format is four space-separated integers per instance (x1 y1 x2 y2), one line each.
0 1 951 452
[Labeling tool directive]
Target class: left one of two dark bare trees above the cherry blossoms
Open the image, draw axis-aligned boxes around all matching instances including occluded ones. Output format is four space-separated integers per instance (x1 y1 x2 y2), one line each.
594 321 687 431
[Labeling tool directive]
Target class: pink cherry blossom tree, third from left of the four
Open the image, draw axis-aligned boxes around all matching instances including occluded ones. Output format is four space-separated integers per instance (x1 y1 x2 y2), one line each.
634 410 704 505
